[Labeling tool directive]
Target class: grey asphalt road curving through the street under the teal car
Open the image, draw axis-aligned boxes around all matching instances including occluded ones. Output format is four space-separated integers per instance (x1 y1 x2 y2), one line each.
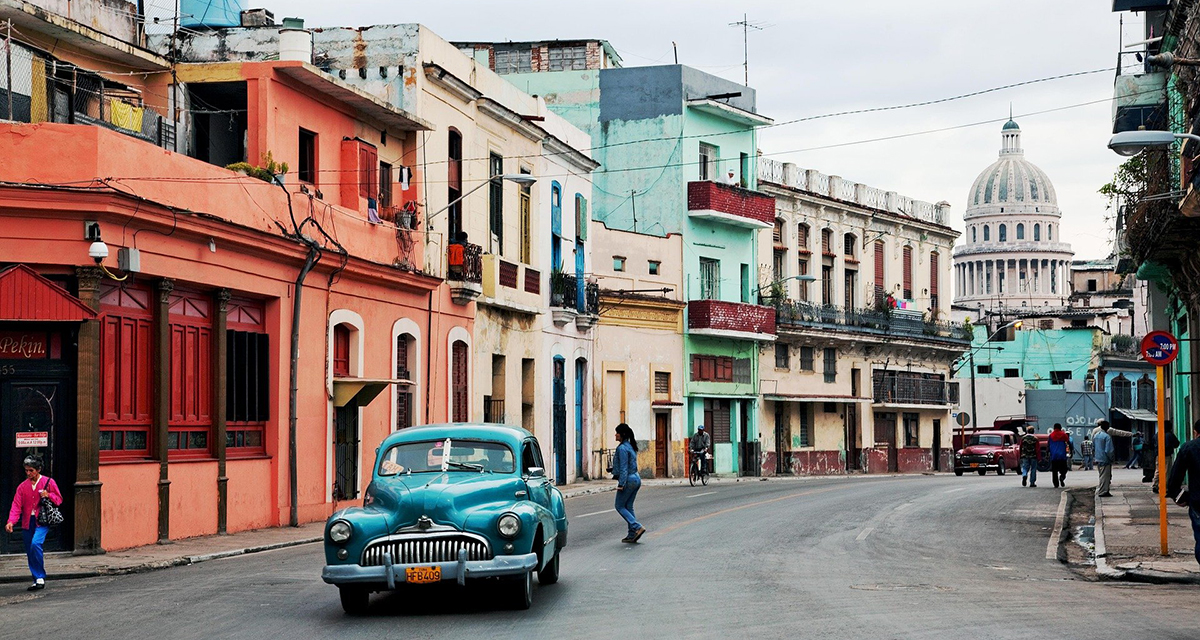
0 475 1200 640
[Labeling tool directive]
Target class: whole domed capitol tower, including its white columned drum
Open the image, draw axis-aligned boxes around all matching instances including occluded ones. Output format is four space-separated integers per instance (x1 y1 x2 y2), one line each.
954 120 1074 313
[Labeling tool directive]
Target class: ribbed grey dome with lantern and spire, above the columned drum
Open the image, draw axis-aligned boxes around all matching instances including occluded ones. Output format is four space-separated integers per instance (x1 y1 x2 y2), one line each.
967 120 1058 211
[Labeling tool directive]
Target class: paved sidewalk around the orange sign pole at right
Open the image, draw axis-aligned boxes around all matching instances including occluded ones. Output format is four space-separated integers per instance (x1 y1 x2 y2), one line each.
1096 471 1200 584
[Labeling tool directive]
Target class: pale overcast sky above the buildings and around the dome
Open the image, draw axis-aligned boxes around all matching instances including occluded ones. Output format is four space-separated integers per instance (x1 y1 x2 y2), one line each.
272 0 1141 258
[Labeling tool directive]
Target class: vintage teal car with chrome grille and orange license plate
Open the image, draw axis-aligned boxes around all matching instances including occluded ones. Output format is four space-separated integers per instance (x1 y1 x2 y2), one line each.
322 424 566 615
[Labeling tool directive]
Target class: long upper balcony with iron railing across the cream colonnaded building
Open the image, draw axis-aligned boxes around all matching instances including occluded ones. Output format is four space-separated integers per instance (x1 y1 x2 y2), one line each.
773 300 971 349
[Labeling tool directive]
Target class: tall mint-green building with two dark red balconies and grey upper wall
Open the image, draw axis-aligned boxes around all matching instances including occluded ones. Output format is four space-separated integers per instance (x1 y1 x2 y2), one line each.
487 46 775 475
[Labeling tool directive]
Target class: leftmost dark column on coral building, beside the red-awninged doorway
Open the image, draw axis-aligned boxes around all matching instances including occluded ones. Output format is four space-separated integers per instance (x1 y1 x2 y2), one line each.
74 267 104 555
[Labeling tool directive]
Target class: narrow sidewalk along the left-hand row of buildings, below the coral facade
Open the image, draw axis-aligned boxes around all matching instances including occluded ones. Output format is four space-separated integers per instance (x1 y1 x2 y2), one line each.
0 478 710 584
